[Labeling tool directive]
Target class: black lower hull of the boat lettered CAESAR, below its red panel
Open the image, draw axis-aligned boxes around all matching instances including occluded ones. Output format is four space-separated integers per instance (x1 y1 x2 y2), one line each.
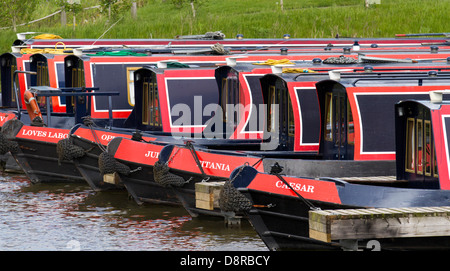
240 189 450 251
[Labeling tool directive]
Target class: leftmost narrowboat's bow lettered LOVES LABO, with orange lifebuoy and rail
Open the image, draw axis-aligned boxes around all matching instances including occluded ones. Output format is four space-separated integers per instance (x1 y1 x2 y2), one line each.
2 86 118 183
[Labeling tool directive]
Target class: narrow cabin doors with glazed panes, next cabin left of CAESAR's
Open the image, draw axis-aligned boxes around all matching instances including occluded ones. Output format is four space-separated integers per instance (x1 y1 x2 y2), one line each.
322 91 352 160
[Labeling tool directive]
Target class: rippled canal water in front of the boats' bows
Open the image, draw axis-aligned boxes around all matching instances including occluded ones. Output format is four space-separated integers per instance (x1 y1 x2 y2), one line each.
0 173 267 251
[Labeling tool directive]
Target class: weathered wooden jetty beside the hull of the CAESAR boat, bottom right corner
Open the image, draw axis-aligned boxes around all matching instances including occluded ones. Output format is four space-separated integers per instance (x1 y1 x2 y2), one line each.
309 206 450 242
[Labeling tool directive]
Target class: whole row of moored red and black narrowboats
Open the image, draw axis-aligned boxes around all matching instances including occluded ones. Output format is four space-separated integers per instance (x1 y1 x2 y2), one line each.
0 35 450 250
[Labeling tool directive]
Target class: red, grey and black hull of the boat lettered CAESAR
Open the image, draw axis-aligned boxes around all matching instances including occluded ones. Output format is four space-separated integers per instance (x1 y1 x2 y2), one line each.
233 169 450 250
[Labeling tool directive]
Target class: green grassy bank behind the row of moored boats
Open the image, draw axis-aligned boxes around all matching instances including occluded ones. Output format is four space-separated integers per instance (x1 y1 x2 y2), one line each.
0 0 450 52
